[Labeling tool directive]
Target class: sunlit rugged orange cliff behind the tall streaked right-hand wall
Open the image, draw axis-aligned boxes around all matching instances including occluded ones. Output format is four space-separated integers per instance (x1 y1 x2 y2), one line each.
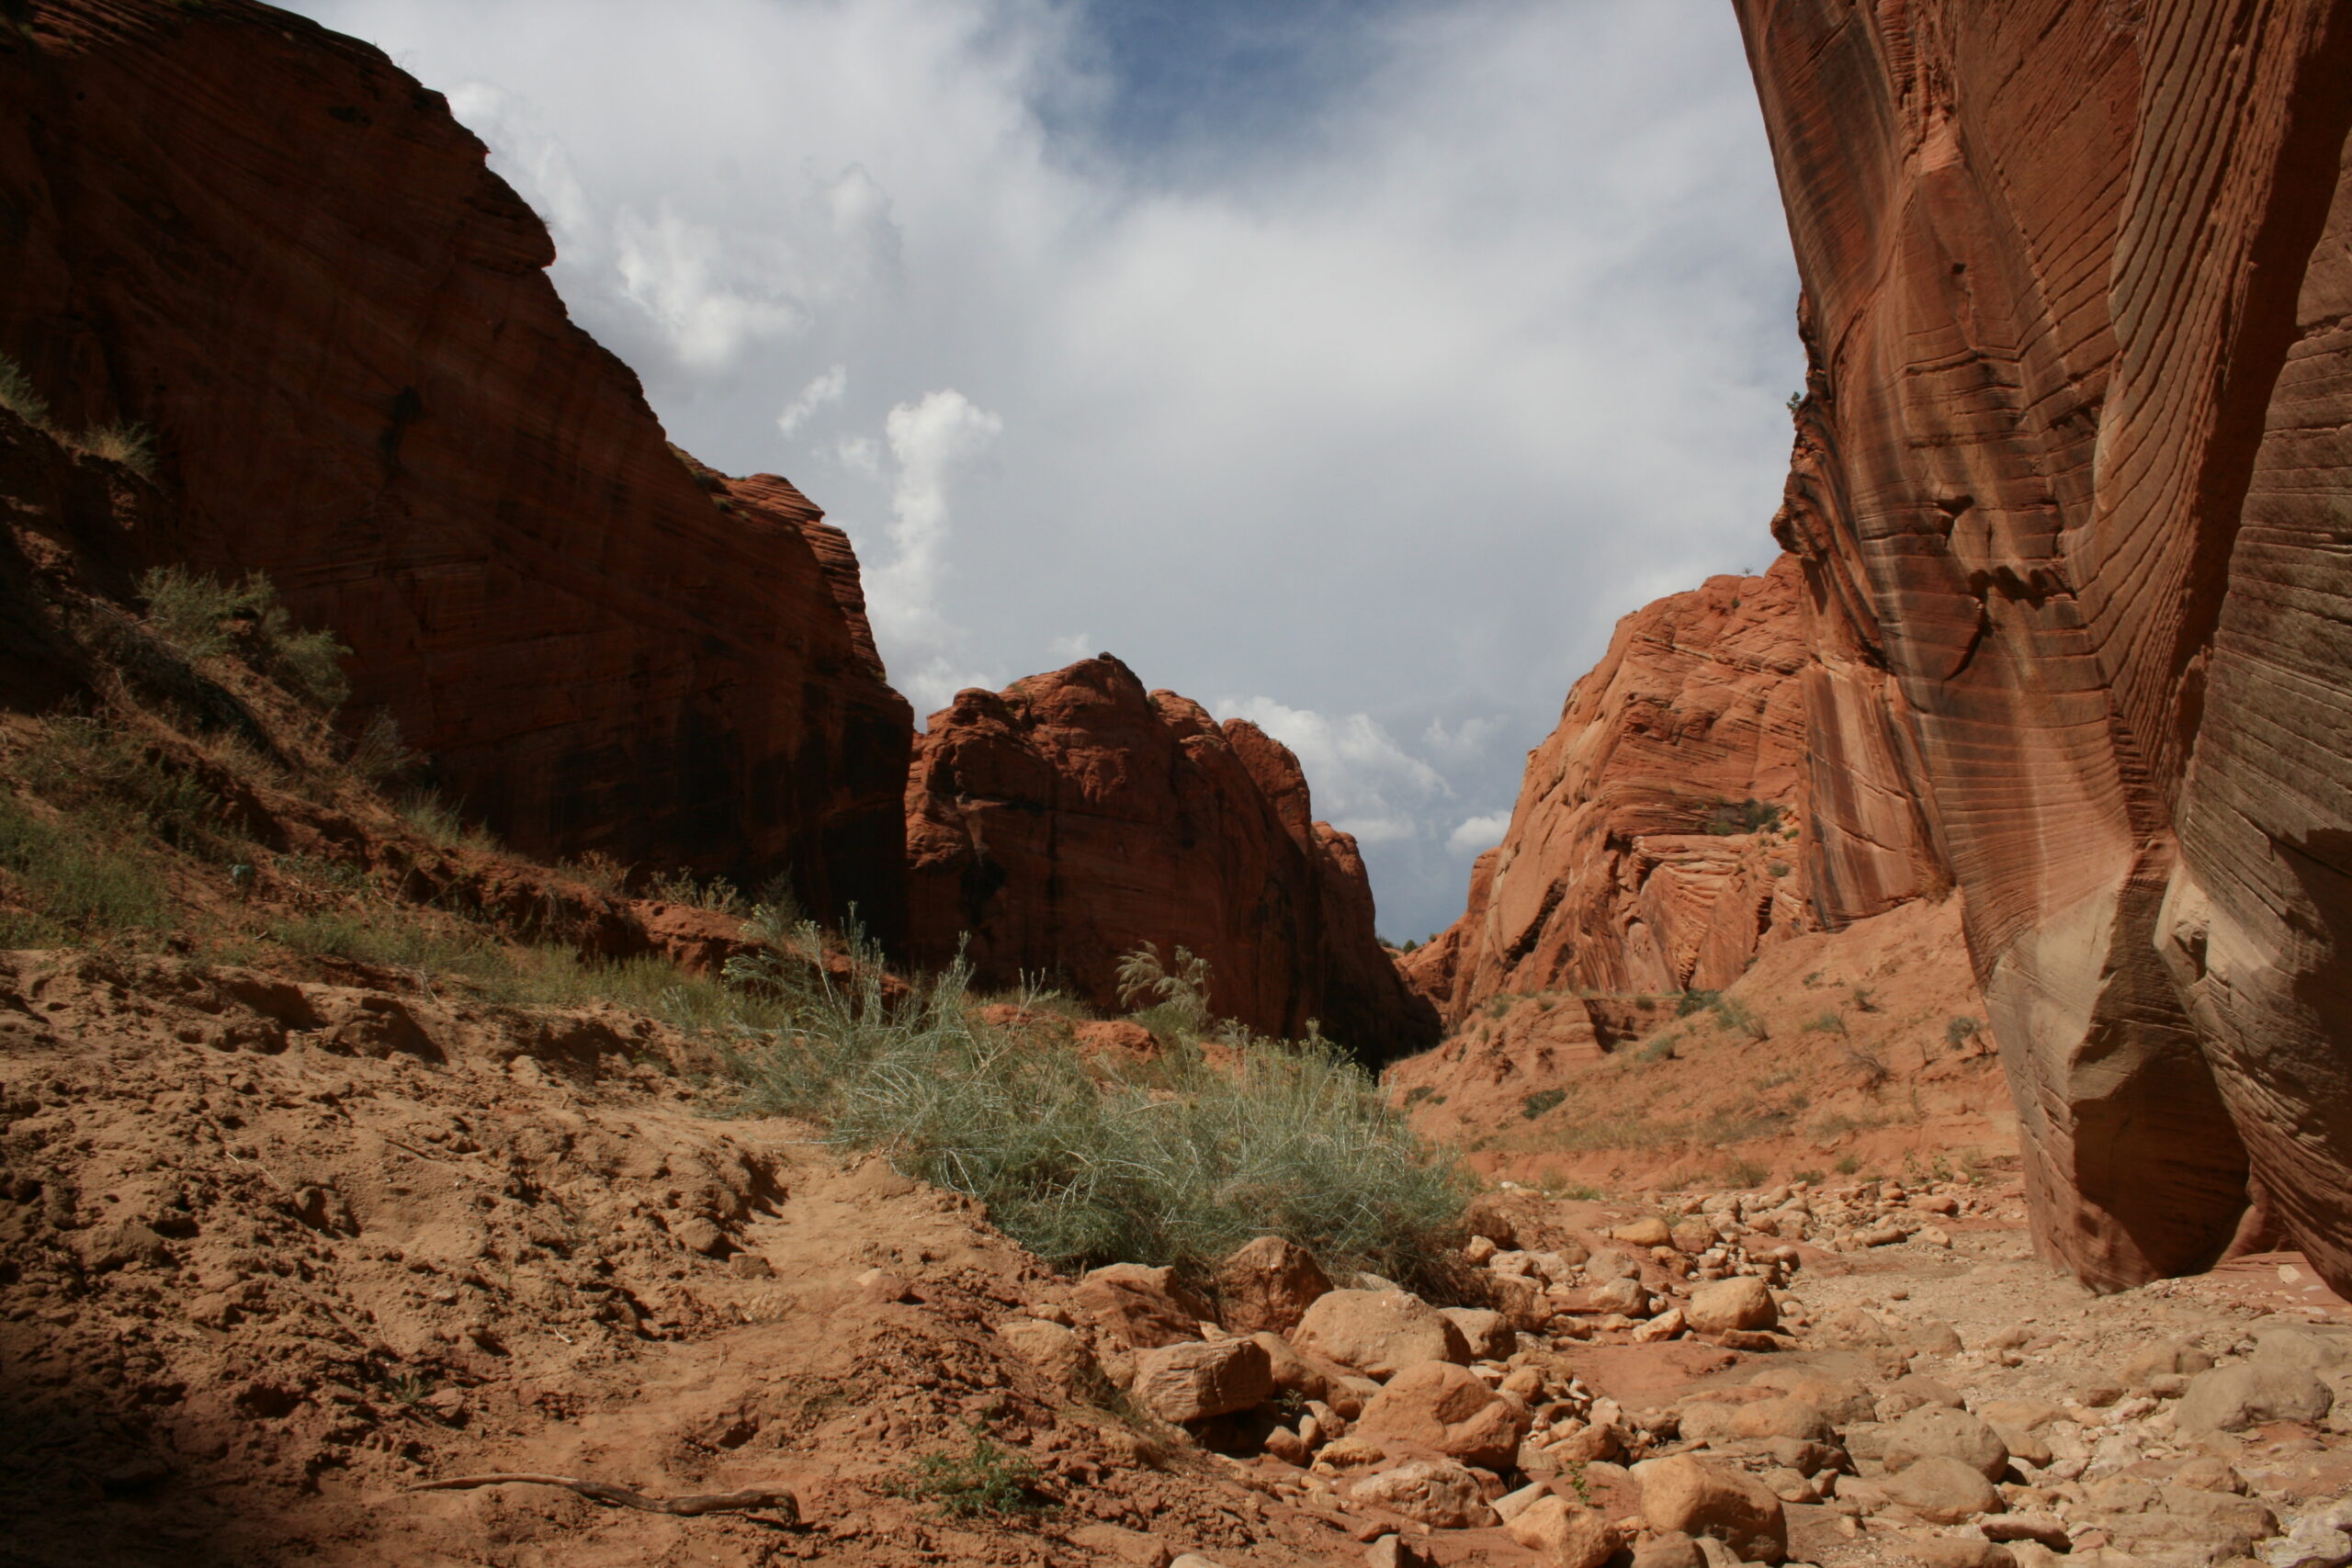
1404 558 1811 1022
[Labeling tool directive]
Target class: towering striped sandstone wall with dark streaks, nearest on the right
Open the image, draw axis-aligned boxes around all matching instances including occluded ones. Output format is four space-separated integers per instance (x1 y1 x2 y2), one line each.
1738 0 2352 1288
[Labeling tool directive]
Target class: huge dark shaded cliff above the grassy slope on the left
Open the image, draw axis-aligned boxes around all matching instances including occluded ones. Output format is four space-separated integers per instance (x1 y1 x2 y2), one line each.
0 0 912 936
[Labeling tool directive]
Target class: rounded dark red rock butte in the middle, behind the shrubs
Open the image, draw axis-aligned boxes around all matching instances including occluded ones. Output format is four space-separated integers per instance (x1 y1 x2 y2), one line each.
906 656 1437 1058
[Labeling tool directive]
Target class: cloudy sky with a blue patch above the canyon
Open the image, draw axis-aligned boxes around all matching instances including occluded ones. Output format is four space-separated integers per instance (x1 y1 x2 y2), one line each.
294 0 1802 941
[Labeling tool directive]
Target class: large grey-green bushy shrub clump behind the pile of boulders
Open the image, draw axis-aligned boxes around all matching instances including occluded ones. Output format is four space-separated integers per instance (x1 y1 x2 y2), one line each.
727 944 1470 1277
